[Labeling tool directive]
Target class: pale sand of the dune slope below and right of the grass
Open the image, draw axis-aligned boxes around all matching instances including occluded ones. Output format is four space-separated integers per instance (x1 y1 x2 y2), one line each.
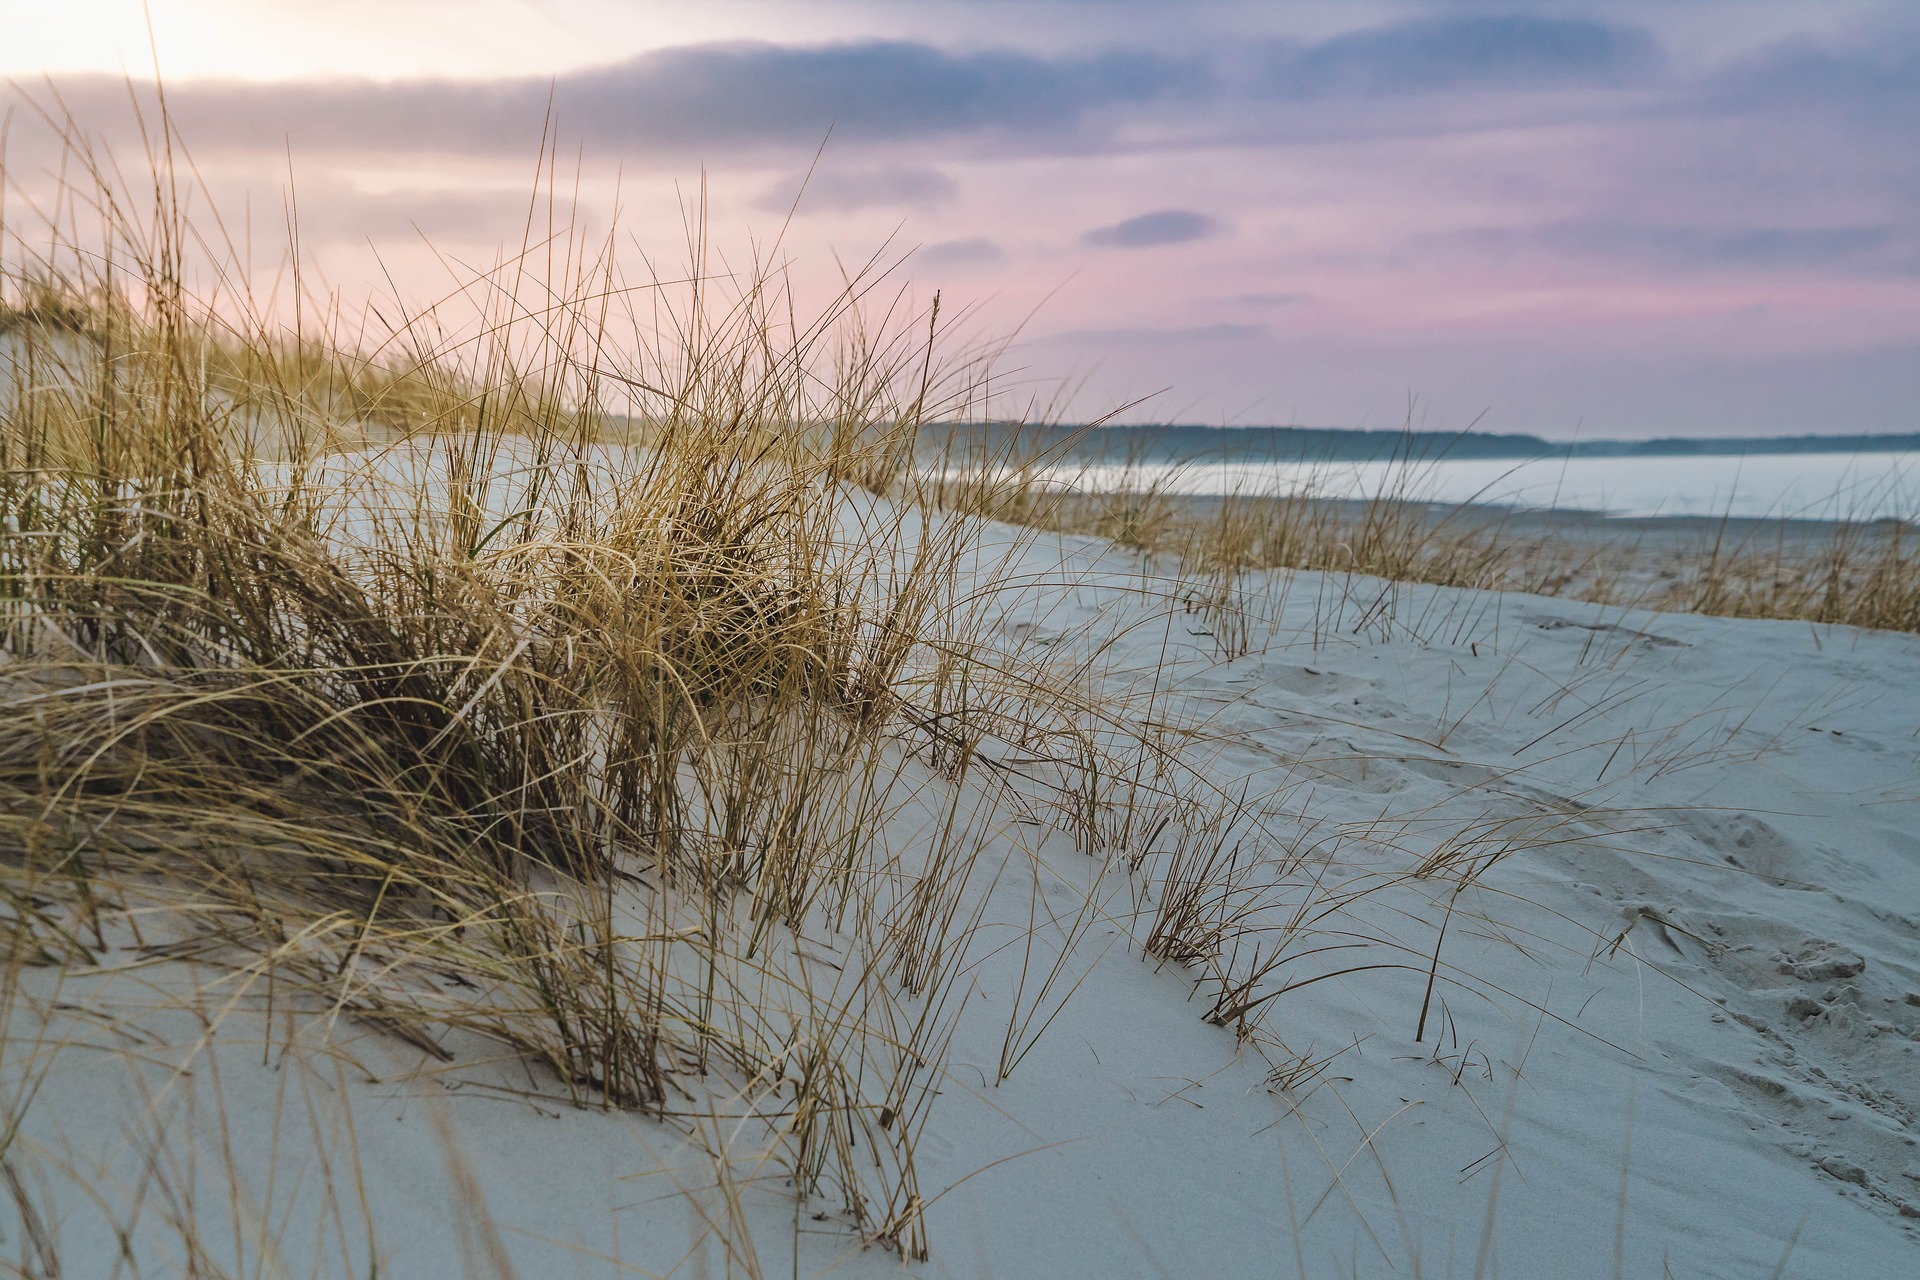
8 506 1920 1280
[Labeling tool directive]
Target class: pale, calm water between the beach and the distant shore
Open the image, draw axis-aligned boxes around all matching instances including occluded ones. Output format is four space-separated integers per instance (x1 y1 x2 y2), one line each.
1043 453 1920 520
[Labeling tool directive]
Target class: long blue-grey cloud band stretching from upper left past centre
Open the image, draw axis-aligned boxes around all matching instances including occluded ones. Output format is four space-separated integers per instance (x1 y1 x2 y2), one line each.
45 40 1208 154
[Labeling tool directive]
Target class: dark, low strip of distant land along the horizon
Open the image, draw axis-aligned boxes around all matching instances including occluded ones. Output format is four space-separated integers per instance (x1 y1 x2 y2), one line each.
920 422 1920 462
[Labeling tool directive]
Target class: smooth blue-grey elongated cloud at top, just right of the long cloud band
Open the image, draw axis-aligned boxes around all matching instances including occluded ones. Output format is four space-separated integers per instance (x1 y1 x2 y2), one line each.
1260 15 1661 98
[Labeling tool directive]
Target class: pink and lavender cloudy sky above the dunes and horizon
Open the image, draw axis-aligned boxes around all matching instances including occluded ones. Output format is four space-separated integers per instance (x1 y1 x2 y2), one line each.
0 0 1920 439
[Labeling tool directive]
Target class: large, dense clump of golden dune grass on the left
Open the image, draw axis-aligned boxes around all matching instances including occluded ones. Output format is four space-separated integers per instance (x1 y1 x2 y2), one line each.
0 100 1052 1255
